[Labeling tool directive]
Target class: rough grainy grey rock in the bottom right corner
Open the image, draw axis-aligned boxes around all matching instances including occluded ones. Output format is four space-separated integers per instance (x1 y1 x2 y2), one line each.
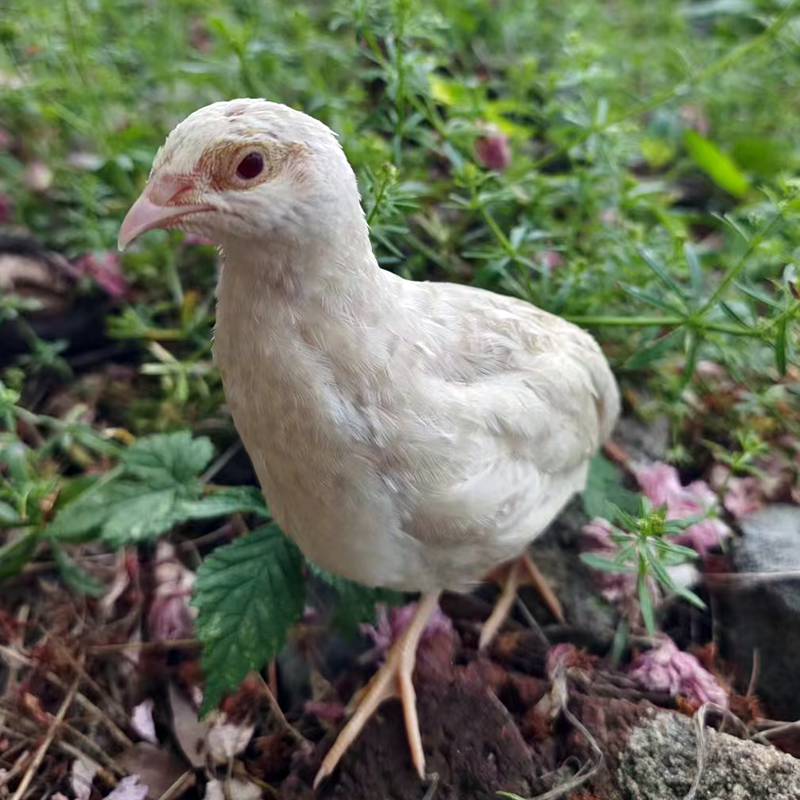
617 711 800 800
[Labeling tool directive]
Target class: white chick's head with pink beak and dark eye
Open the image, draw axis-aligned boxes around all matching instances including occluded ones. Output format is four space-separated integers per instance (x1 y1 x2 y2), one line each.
118 99 361 250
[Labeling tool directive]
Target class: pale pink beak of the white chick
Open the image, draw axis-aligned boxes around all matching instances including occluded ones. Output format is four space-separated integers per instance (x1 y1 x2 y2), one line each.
117 176 213 251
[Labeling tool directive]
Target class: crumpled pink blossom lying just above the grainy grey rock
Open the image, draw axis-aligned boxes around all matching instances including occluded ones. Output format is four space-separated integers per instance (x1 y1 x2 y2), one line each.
631 636 728 708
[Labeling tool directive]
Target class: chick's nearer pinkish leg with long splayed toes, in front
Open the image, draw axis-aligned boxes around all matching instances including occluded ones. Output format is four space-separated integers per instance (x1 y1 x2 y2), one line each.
314 592 439 789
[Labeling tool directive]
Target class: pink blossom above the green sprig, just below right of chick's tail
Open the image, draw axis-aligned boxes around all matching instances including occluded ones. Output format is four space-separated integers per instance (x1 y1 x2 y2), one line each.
636 461 730 555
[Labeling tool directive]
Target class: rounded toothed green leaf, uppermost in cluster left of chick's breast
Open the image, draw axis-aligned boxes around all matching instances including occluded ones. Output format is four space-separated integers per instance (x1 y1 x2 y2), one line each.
122 431 214 487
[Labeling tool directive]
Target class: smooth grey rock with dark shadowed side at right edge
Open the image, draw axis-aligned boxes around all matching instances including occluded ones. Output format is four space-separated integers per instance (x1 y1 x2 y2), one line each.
717 504 800 719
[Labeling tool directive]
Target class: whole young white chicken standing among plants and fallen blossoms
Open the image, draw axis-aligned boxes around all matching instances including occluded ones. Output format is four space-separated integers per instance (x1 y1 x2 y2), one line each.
119 99 619 783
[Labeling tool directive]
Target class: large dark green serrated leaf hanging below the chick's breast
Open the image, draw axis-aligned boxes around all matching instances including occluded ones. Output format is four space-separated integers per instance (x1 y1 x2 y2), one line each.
192 525 305 714
